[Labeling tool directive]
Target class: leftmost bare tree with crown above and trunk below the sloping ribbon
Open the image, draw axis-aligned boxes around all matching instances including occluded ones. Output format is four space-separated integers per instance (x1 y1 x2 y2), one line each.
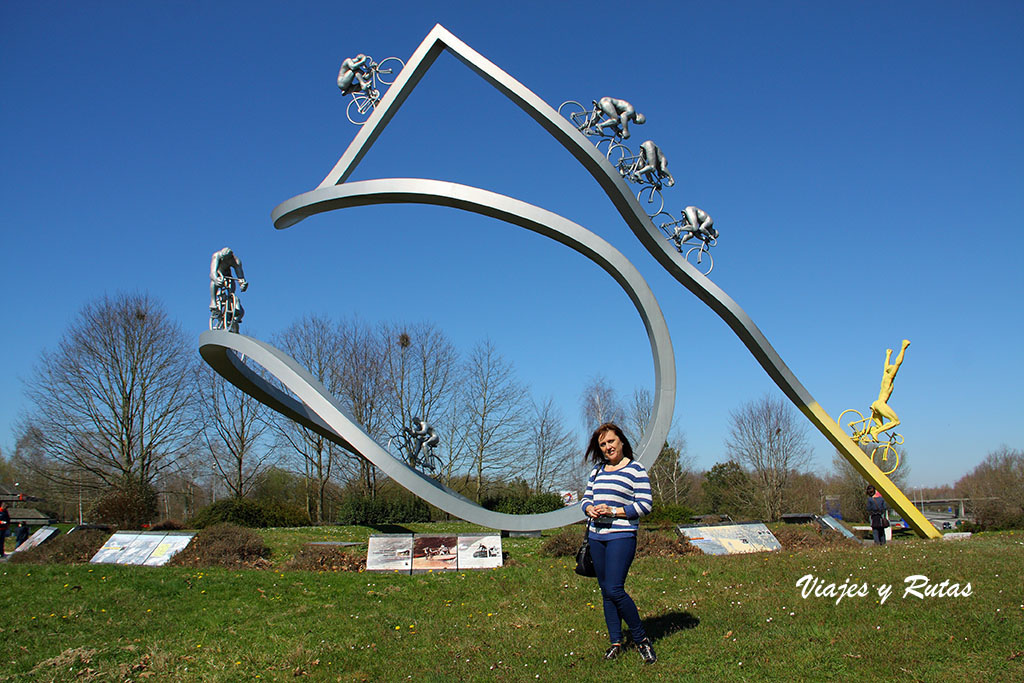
273 315 344 524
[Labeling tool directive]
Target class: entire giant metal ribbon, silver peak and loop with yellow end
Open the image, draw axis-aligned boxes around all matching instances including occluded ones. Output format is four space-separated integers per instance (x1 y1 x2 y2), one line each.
200 25 938 537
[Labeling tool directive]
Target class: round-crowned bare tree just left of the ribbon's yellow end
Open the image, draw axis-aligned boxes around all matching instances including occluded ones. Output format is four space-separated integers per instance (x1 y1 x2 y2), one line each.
725 395 811 521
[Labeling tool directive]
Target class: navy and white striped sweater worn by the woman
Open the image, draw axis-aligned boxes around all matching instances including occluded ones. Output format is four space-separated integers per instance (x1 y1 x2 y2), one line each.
580 460 653 539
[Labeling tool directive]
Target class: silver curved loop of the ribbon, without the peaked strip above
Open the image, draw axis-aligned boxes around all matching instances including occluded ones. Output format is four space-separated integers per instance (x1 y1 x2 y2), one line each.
200 178 676 531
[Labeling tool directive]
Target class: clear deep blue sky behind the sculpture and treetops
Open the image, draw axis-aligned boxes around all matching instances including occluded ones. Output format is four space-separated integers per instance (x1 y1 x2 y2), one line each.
0 1 1024 485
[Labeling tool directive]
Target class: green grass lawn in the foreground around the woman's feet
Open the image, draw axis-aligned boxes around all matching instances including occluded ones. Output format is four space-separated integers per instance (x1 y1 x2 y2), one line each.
0 523 1024 681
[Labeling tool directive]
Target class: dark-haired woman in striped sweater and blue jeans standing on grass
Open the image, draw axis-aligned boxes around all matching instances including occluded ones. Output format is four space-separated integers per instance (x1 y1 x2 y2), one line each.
582 422 657 664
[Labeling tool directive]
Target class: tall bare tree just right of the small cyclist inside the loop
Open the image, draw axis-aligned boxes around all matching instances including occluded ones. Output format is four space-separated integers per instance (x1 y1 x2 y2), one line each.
460 340 526 500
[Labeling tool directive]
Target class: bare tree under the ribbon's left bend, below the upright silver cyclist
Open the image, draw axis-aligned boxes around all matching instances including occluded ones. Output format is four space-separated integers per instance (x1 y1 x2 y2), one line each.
198 369 272 498
